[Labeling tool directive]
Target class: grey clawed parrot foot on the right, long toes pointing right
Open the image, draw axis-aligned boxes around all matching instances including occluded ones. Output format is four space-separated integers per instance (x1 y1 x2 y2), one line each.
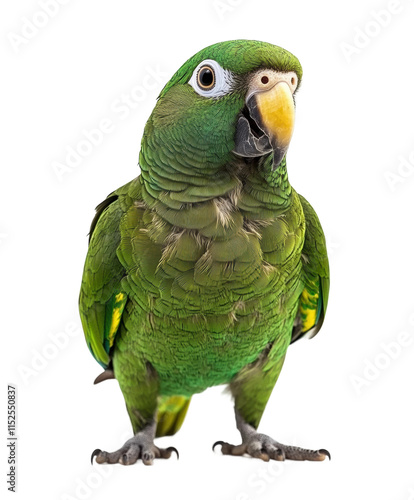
213 410 331 462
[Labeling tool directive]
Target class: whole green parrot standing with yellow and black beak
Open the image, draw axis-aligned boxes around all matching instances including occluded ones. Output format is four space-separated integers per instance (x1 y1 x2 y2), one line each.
79 40 330 465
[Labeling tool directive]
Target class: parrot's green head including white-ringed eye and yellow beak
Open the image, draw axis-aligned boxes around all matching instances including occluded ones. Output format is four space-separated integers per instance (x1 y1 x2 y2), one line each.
143 40 302 178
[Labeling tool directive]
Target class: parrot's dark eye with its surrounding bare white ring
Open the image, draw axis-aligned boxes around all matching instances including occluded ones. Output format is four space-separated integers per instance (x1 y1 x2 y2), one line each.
188 59 233 97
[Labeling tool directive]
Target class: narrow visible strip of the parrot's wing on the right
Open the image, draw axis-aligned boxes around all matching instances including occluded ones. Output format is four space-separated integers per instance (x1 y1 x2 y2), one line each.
291 195 329 343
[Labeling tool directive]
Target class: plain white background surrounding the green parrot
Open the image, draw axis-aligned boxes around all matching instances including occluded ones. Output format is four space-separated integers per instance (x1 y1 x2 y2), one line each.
0 0 414 500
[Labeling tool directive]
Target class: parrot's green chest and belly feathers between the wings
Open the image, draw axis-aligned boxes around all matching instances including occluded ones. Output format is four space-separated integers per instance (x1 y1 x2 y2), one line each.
118 186 305 393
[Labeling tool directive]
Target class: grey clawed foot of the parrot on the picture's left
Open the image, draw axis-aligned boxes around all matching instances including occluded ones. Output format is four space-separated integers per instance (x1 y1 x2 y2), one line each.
91 421 178 465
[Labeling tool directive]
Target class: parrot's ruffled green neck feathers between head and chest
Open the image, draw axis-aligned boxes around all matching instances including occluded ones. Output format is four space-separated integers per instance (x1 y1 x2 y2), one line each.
139 125 292 222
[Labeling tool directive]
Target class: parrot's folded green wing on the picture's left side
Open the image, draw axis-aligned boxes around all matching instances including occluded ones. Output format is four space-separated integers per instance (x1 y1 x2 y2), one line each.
79 188 128 369
